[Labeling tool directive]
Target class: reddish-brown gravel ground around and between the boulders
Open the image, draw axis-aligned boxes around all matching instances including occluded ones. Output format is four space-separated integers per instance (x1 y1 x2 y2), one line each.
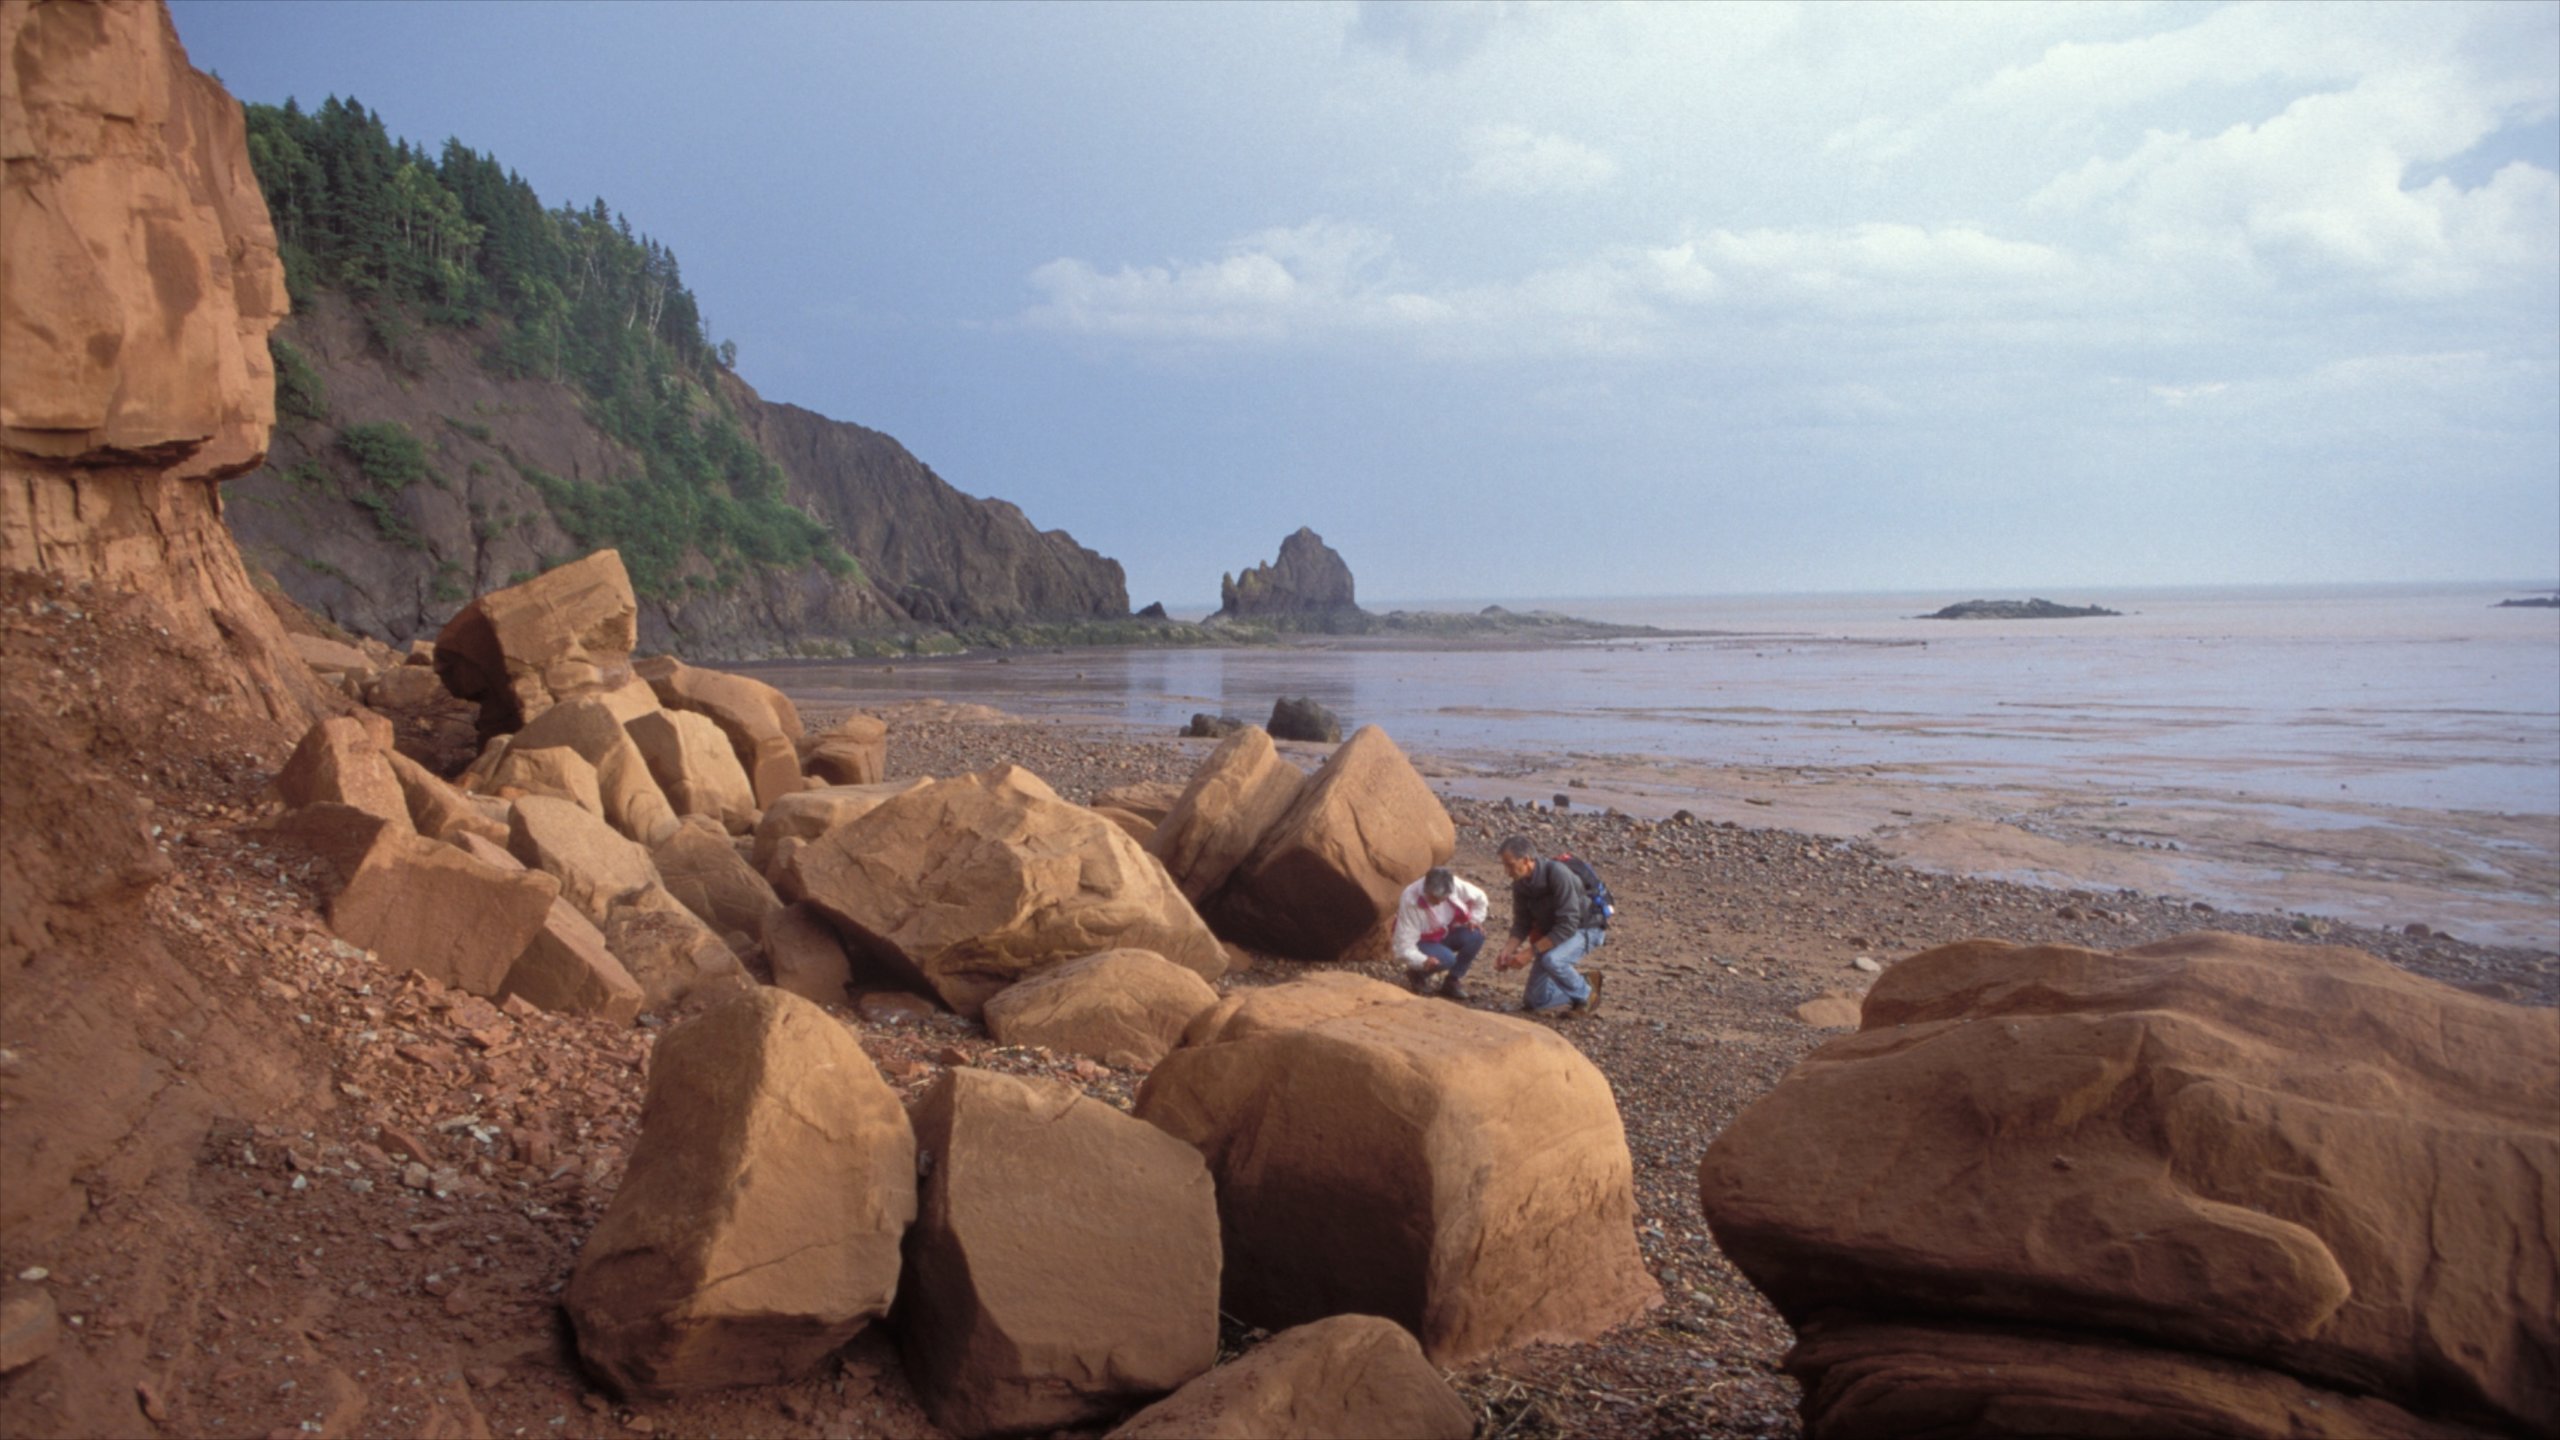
0 638 2560 1437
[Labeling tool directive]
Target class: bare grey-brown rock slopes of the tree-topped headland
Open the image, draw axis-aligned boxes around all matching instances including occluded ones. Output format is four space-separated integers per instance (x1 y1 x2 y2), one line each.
230 304 1129 659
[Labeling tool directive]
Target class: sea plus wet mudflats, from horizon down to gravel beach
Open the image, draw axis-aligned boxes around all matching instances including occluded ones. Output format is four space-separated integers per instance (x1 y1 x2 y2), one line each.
755 584 2560 948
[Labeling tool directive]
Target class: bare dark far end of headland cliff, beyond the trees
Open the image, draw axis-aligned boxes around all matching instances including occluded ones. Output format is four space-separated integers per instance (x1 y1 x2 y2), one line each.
737 384 1129 625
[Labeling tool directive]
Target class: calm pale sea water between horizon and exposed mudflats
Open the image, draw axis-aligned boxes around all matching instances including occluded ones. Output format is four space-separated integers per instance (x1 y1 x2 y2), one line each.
758 573 2560 817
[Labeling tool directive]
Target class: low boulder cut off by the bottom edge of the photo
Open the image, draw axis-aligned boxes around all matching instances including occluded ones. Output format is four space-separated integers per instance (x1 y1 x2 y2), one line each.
1111 1314 1475 1440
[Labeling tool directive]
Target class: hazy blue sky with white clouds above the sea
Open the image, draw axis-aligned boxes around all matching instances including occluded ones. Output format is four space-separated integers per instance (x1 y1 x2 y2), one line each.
172 0 2560 610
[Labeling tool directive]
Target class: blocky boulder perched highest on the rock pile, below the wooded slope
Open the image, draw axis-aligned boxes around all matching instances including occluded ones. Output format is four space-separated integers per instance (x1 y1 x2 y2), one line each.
435 551 640 735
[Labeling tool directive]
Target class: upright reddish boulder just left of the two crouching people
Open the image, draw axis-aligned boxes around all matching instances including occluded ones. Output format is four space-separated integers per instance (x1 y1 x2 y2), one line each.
1203 725 1457 961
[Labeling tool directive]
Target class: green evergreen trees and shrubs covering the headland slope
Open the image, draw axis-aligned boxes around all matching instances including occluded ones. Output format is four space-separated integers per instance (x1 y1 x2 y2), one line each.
248 97 858 600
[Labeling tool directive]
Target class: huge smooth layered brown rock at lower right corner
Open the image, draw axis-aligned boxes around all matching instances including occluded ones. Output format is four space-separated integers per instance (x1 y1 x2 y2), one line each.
1700 935 2560 1435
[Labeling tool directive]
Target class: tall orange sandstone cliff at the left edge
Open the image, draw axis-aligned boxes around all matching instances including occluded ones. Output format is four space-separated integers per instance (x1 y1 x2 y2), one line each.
0 0 338 730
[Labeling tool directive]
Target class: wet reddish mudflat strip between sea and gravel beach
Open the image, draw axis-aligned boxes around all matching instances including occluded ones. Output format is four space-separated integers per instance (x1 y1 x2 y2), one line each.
765 674 2560 956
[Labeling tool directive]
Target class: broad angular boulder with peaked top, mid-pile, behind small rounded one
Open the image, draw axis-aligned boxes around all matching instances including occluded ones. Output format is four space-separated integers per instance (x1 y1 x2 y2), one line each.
776 766 1226 1017
